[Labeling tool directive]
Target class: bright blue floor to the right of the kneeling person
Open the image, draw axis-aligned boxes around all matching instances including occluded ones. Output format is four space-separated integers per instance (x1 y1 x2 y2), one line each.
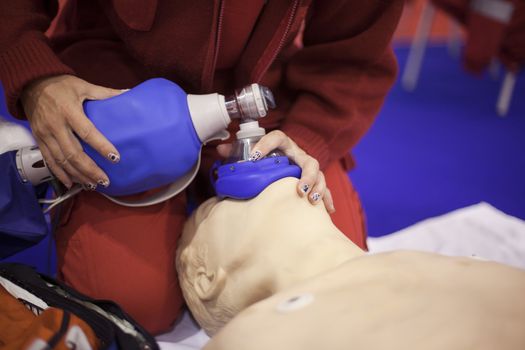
350 46 525 236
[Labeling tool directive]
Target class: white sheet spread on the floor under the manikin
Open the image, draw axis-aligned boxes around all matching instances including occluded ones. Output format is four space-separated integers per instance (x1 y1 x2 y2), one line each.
156 203 525 350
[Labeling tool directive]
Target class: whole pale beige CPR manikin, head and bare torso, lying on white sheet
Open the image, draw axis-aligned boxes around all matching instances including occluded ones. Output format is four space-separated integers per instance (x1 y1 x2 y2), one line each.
177 178 525 350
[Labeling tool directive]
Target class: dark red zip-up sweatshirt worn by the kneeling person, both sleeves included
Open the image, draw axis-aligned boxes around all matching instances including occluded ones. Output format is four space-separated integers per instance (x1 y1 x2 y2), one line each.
0 0 403 172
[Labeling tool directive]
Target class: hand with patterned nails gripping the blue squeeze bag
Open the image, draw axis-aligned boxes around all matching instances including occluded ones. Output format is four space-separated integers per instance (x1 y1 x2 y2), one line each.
21 75 122 190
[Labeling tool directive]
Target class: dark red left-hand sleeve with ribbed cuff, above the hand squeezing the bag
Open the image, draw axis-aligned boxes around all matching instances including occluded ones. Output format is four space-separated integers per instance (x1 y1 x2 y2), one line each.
0 0 73 118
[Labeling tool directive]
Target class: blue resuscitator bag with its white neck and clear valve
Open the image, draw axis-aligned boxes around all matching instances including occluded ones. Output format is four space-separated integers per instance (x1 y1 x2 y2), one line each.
11 78 274 210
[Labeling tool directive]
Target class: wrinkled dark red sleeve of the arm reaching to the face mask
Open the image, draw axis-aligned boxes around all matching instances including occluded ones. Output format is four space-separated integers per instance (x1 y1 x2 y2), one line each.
282 0 404 169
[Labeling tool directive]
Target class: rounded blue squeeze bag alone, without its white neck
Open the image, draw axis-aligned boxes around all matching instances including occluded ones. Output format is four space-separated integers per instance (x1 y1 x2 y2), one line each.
82 78 201 196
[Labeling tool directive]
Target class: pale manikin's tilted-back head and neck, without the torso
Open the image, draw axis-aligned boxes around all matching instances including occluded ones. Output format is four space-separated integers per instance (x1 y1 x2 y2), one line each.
176 178 364 335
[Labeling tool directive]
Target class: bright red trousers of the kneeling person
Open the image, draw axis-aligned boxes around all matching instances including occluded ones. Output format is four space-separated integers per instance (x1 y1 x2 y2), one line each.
56 162 366 334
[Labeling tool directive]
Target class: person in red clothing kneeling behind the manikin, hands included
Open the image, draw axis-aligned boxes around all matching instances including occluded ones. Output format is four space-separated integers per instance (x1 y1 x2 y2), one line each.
0 0 403 333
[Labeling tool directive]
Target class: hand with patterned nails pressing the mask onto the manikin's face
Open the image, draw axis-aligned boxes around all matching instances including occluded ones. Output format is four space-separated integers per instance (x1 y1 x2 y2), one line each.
217 130 335 213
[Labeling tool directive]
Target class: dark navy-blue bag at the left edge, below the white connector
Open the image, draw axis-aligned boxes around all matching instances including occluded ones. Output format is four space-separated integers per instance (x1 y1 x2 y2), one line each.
0 151 48 259
